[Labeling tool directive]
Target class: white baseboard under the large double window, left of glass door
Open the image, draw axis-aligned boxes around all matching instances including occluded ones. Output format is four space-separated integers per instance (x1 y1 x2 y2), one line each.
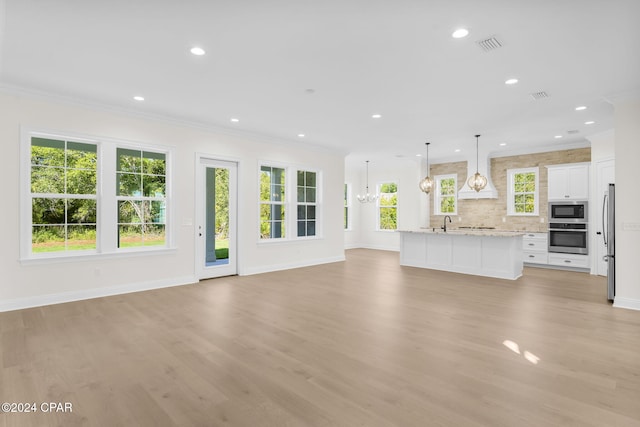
0 276 198 312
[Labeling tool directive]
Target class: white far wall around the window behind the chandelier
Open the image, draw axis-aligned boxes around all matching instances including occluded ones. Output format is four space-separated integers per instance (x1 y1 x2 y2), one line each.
345 156 428 251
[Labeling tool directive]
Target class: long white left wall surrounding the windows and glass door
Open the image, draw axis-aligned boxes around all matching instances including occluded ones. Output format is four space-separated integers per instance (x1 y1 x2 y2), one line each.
0 92 344 311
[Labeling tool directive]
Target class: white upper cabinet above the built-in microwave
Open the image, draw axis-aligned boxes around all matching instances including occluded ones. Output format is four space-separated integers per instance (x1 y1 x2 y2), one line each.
547 163 589 201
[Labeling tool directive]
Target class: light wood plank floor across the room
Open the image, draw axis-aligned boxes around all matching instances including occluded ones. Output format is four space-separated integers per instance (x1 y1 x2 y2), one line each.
0 250 640 427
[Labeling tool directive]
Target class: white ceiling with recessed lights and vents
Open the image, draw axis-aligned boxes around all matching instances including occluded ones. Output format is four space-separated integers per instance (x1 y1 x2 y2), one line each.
0 0 640 161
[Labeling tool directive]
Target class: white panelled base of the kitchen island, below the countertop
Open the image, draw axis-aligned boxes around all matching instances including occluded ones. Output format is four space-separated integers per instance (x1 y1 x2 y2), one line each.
399 229 524 280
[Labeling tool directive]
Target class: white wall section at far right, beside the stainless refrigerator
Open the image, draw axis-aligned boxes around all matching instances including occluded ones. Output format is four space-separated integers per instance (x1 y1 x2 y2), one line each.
614 99 640 310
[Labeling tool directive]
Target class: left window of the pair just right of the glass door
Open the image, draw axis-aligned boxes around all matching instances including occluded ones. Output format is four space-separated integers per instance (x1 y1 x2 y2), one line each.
260 165 287 239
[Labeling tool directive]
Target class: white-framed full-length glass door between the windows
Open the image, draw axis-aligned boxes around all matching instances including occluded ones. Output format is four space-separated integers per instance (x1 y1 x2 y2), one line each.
196 156 237 279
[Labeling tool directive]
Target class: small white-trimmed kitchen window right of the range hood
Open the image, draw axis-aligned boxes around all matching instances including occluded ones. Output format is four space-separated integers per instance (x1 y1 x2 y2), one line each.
507 167 539 216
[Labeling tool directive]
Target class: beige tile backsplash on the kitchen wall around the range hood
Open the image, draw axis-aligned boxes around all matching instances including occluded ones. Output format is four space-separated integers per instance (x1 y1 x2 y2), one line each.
429 148 591 232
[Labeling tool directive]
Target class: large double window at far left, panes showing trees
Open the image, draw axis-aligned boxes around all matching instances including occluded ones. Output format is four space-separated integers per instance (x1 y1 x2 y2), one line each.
21 132 169 259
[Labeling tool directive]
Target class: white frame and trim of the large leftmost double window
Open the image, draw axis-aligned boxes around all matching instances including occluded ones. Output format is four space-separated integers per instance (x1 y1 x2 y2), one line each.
20 127 175 263
